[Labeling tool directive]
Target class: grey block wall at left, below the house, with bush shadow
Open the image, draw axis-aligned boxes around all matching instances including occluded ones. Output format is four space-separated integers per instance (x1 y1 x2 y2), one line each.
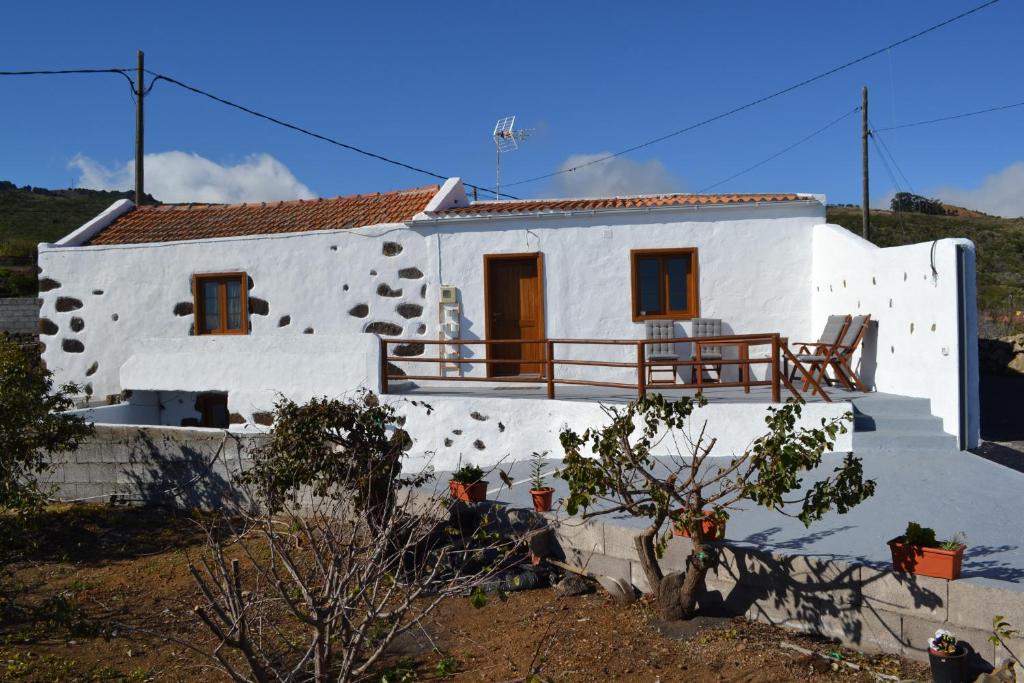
49 425 266 509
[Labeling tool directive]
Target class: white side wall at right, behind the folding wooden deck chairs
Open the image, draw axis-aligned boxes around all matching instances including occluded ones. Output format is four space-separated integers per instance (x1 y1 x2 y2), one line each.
809 225 980 446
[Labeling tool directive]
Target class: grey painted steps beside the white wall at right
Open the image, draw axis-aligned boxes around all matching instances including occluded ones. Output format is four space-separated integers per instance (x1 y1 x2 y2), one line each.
850 393 957 454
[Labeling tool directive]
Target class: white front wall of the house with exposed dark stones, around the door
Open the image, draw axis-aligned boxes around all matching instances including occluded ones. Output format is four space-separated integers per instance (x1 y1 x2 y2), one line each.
39 202 824 409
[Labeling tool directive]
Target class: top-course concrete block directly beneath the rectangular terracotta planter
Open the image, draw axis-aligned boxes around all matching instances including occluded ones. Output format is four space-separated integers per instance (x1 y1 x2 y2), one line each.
860 566 949 622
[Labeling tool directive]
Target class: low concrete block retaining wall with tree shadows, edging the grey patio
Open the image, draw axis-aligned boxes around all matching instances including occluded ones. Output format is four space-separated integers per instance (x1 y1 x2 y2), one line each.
553 519 1024 664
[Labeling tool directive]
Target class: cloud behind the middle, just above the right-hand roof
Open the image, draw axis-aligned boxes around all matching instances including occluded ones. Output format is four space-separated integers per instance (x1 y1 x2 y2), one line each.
555 152 683 197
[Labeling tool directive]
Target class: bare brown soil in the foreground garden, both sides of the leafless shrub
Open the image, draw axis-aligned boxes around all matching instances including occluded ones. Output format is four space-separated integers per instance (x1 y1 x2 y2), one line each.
0 506 928 683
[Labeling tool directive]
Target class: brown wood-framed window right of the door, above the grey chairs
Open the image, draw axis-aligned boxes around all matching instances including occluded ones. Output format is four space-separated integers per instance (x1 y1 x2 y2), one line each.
630 249 700 321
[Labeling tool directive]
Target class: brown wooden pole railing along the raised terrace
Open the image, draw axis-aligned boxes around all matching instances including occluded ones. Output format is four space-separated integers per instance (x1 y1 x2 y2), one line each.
381 334 831 402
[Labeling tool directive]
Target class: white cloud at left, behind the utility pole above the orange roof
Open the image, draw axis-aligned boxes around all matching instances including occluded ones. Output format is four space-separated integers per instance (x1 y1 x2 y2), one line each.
69 152 316 204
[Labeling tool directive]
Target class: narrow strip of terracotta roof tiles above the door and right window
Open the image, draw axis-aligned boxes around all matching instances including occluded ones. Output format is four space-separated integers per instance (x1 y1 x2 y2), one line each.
433 194 807 217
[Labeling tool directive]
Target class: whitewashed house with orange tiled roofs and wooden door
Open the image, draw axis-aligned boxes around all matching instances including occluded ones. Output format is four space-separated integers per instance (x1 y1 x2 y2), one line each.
39 178 979 461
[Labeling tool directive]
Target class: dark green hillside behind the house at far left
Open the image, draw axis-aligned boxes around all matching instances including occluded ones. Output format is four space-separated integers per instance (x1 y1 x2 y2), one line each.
0 180 156 297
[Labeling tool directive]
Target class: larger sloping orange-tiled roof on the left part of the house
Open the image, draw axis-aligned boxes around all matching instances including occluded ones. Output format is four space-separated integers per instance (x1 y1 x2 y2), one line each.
88 185 438 245
